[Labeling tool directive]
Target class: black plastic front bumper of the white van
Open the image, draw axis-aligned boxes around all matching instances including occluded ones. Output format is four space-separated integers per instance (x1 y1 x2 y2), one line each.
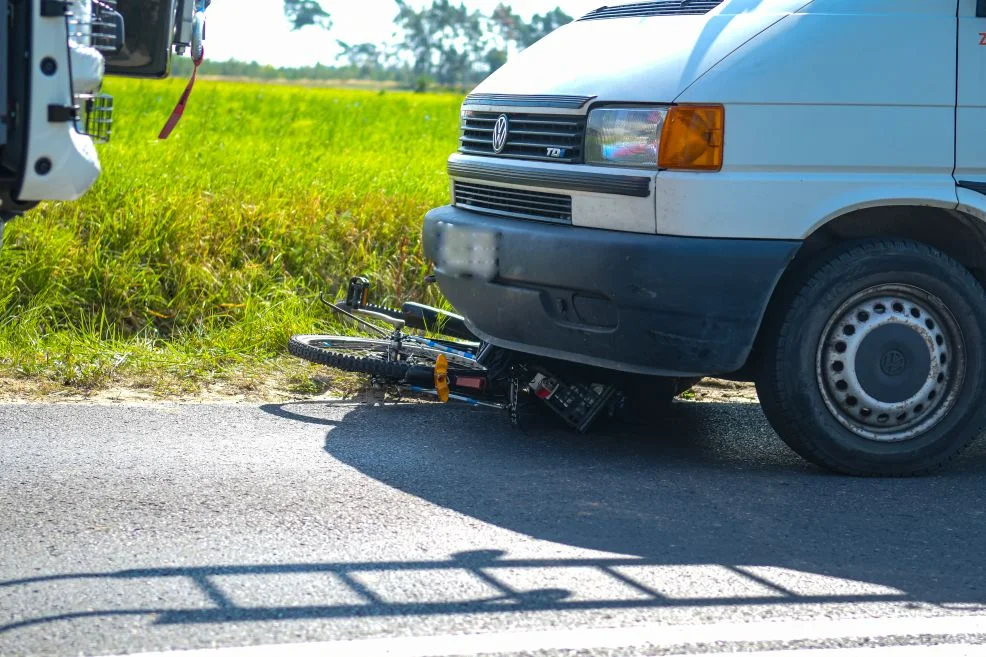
424 206 800 376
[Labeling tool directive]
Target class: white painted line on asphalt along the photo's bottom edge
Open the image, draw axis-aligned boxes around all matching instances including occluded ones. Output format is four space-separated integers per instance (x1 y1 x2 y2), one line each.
100 616 986 657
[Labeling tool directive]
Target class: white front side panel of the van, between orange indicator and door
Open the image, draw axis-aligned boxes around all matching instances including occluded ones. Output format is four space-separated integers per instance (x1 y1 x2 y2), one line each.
656 0 958 239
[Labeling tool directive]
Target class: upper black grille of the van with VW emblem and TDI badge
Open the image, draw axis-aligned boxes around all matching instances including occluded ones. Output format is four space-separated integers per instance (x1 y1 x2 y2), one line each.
459 111 585 164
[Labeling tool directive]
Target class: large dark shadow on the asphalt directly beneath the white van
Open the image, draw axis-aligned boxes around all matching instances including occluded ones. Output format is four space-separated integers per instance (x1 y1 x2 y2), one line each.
294 394 986 605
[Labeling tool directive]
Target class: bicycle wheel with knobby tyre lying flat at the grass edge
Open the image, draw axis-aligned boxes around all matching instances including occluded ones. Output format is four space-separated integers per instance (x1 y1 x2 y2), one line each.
288 335 413 381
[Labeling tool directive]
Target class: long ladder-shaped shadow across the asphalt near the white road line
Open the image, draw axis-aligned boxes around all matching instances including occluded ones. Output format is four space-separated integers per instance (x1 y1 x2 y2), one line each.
0 550 912 635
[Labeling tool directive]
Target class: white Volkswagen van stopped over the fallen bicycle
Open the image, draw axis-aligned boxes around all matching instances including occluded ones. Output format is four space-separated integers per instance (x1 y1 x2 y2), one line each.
424 0 986 475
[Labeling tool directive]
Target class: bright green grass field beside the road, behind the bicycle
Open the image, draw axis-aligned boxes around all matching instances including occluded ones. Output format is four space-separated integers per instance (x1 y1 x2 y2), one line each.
0 80 461 394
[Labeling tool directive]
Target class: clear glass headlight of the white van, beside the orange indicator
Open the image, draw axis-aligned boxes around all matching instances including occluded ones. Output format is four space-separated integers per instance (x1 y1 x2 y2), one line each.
585 107 668 169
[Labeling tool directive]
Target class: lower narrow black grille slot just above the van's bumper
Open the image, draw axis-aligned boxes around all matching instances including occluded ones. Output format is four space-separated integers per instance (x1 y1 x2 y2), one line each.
452 181 572 224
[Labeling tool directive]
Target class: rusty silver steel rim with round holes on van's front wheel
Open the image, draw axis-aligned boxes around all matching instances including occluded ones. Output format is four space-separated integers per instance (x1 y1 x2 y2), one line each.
815 285 966 443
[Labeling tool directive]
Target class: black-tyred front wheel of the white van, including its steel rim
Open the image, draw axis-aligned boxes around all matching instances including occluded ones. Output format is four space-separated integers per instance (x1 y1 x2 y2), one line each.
757 240 986 476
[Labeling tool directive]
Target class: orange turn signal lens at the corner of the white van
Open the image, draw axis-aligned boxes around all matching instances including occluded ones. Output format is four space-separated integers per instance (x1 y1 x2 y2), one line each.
658 105 726 171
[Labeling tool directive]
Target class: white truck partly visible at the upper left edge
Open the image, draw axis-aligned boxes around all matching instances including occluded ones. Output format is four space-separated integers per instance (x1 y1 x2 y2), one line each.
0 0 208 237
